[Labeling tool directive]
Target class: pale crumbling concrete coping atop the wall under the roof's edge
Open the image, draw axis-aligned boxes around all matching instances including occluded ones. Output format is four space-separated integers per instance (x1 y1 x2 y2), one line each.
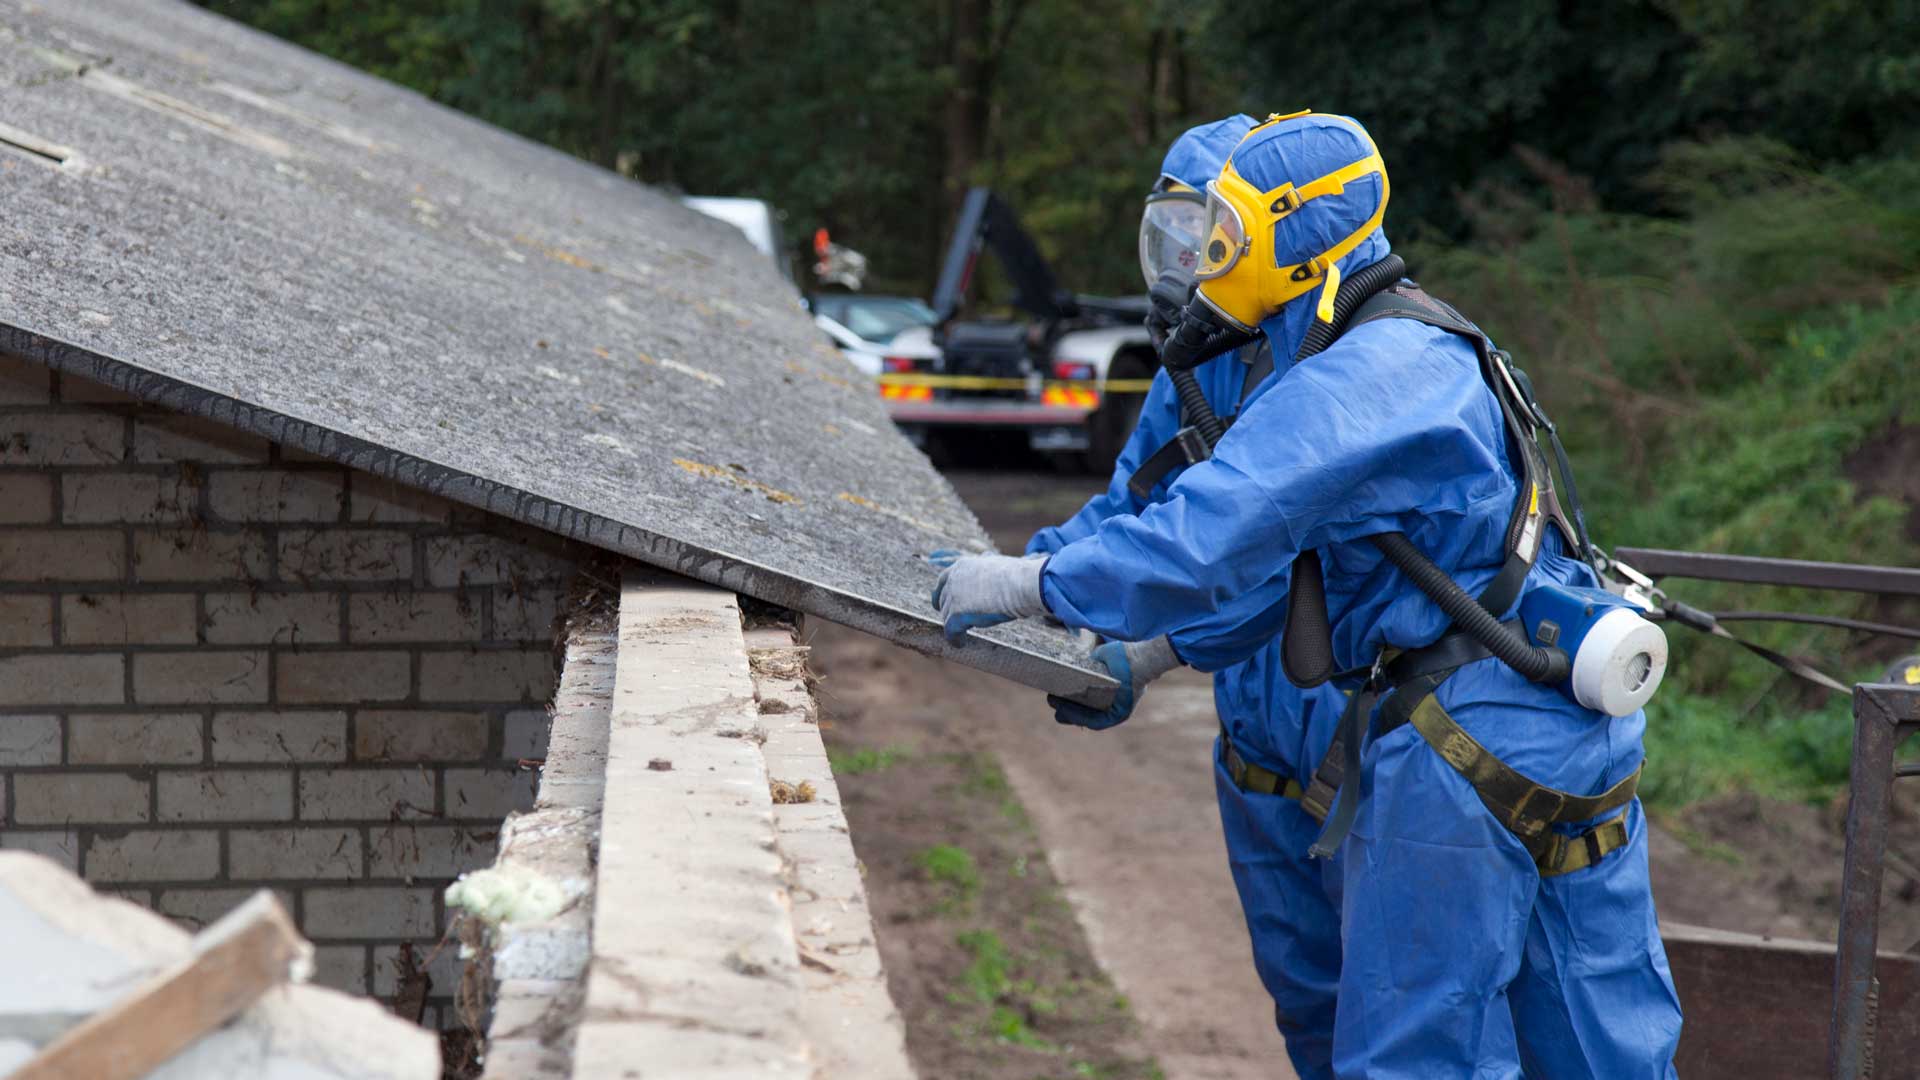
466 569 914 1078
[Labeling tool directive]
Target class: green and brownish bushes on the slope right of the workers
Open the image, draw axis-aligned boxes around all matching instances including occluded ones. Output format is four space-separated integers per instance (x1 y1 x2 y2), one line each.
1413 140 1920 807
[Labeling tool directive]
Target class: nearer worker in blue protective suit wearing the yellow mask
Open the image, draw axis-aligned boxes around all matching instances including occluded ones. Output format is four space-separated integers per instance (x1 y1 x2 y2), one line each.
935 113 1680 1080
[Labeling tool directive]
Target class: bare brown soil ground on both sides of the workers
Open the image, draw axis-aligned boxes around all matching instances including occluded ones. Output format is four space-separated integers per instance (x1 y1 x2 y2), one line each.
810 471 1920 1080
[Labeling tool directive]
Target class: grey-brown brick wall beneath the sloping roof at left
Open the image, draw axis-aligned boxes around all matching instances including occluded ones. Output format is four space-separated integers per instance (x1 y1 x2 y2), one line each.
0 357 582 1005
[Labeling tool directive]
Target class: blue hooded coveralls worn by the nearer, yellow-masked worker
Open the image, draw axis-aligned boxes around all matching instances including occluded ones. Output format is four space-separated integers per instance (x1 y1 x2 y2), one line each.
1041 115 1680 1080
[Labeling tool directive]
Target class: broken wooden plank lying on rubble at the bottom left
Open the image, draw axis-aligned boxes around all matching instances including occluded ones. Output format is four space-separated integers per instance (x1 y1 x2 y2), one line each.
12 890 313 1080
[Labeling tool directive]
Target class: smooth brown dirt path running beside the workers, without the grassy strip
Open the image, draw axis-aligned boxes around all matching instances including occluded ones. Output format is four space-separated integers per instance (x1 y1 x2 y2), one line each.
812 473 1292 1080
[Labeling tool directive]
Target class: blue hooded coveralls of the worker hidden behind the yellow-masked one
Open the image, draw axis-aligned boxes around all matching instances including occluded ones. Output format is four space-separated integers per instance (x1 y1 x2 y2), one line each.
1027 115 1365 1080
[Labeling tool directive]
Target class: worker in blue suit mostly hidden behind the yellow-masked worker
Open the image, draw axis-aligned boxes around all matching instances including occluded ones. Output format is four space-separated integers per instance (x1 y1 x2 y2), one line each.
1027 115 1344 1080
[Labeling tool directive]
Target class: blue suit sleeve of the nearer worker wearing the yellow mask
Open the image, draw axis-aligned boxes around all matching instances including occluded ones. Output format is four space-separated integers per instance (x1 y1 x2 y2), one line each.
1043 319 1513 671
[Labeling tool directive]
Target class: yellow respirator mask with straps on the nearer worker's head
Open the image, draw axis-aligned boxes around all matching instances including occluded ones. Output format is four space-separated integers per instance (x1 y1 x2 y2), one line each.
1194 111 1388 331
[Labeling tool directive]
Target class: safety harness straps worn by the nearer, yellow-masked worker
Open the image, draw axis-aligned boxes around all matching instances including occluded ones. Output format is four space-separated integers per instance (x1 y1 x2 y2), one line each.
1221 281 1640 876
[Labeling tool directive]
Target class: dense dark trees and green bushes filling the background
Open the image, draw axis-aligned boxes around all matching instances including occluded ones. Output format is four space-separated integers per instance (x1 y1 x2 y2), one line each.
204 0 1920 805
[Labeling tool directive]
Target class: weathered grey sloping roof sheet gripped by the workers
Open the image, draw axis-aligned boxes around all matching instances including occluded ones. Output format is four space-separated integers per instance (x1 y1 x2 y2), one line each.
0 0 1112 701
